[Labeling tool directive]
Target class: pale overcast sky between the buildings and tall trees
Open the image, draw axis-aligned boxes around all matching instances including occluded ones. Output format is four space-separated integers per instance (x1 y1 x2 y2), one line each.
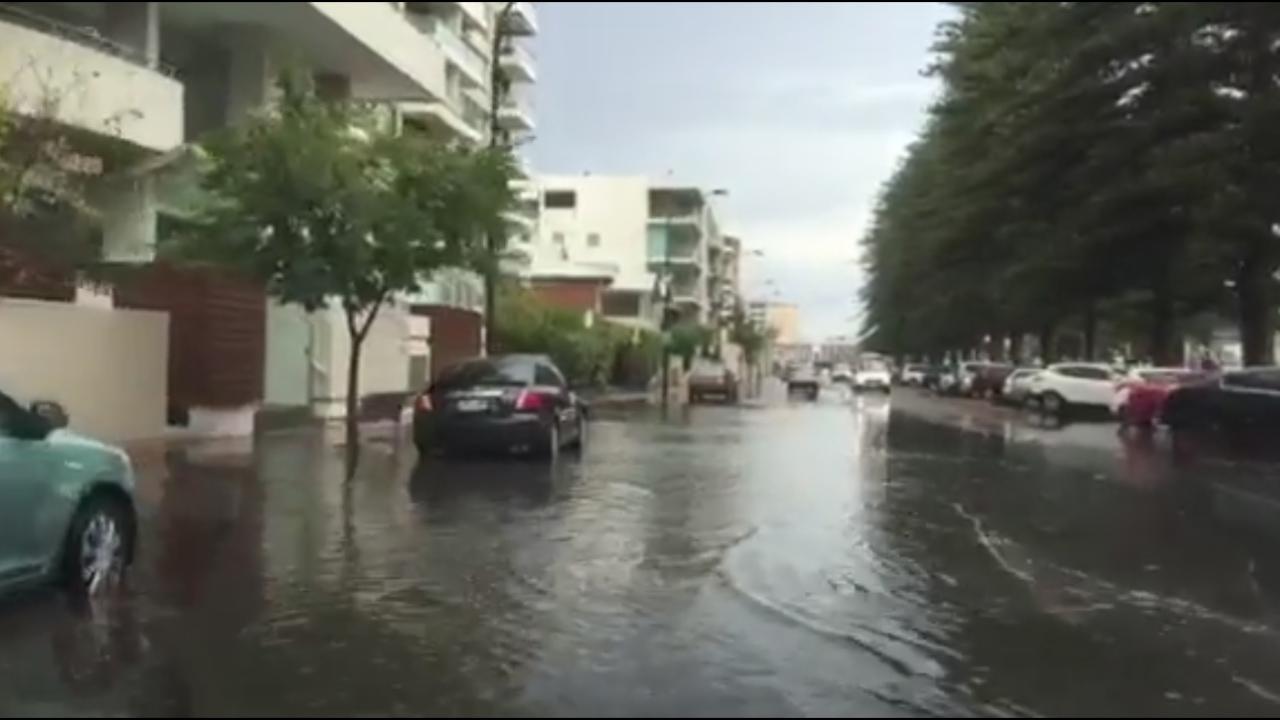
531 3 950 340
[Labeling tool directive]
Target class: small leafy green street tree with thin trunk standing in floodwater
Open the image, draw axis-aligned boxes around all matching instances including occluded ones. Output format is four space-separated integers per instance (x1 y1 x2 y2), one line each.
184 76 509 468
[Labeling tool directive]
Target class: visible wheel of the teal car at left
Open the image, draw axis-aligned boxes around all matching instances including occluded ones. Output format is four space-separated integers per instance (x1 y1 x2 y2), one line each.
63 495 133 597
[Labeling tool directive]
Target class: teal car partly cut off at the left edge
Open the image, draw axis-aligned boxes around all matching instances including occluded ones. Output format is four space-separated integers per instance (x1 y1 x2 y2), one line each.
0 392 137 596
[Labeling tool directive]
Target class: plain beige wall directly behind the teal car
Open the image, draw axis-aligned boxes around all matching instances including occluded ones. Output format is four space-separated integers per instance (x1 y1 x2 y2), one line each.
0 299 169 441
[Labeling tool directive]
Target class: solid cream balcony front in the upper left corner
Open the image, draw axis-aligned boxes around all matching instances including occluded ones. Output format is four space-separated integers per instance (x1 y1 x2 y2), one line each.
0 6 183 152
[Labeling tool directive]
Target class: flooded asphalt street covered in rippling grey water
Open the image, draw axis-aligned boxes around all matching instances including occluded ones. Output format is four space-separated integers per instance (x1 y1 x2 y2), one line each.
0 384 1280 716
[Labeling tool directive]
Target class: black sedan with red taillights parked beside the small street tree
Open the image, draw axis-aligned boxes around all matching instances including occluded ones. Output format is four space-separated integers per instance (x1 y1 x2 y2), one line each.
413 355 586 457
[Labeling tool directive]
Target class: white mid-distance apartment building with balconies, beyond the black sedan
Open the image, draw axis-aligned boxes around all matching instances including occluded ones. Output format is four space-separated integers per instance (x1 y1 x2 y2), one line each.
525 176 740 329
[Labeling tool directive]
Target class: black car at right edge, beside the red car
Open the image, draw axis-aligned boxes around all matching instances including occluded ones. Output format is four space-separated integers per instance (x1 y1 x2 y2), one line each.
1161 366 1280 433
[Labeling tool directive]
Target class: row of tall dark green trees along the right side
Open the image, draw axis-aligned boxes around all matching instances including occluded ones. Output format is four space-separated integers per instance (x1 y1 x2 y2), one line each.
863 3 1280 364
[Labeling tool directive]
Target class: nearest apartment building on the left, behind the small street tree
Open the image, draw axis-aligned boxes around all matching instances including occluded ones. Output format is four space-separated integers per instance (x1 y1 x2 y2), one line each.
0 3 536 439
